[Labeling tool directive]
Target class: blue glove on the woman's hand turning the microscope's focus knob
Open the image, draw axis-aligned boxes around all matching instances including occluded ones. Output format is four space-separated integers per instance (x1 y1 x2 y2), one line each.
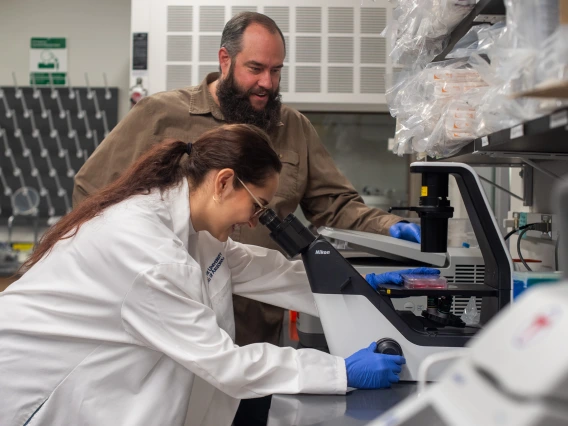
345 342 406 389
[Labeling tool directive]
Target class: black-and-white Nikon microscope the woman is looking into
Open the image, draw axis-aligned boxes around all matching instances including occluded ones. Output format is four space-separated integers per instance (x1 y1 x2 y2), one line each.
260 162 512 381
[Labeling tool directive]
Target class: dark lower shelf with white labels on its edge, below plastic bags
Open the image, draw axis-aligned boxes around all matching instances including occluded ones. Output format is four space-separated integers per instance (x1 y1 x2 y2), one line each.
429 108 568 166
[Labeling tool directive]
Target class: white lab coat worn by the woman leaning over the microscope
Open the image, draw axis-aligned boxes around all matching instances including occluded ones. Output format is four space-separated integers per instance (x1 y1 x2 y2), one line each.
0 182 347 426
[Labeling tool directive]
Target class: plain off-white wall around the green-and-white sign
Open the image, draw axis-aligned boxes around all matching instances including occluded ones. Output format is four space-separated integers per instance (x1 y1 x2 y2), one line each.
0 0 131 119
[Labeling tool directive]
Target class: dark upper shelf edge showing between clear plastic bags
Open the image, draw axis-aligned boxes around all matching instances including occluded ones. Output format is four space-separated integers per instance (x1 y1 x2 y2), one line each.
432 0 505 62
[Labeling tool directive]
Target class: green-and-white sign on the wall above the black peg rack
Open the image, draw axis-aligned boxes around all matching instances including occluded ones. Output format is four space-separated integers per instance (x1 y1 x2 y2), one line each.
30 37 67 86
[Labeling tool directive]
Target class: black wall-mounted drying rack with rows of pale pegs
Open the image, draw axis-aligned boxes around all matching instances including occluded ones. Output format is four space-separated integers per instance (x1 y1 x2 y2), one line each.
0 86 118 218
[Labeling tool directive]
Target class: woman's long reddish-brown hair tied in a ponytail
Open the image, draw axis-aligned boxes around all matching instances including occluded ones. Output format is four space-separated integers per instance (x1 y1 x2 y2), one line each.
18 124 282 272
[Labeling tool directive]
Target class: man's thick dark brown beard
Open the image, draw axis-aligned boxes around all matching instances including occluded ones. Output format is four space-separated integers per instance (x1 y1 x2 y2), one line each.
217 66 282 132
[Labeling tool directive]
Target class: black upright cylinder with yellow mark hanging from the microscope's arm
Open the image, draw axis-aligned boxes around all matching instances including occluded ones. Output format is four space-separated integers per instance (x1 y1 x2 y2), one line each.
420 172 454 253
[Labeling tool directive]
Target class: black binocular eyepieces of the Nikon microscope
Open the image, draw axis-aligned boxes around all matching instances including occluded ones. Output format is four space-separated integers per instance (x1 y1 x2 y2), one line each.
258 209 316 257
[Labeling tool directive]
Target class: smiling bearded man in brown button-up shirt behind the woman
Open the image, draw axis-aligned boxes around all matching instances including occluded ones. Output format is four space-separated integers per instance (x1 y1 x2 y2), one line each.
73 12 420 426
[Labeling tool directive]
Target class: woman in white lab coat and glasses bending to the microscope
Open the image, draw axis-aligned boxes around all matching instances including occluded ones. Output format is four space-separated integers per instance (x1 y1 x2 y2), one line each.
0 125 404 426
